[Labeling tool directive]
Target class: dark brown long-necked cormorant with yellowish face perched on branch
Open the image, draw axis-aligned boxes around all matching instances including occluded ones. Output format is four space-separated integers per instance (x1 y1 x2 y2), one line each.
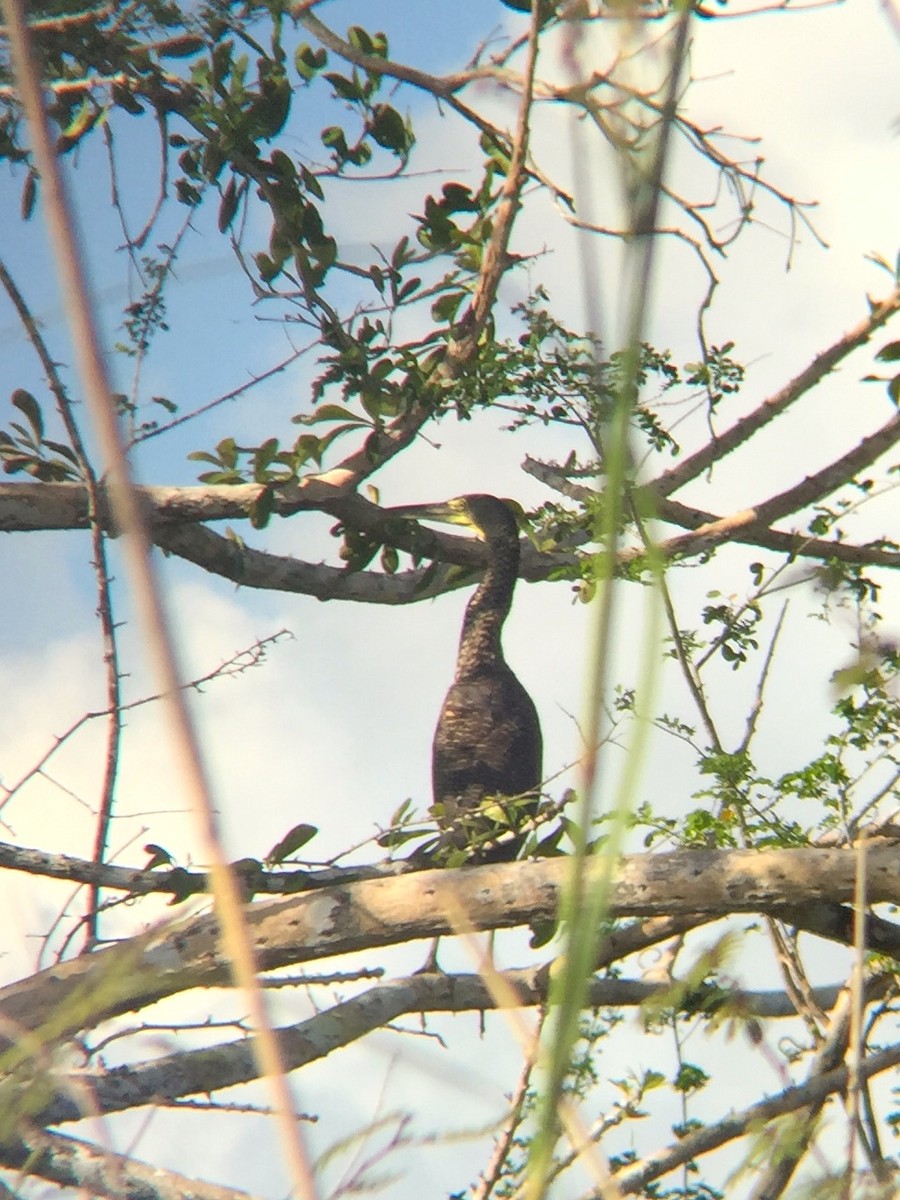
389 494 542 863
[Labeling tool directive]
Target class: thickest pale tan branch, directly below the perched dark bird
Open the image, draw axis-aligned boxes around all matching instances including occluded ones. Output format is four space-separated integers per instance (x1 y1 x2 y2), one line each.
0 846 900 1051
